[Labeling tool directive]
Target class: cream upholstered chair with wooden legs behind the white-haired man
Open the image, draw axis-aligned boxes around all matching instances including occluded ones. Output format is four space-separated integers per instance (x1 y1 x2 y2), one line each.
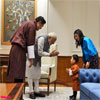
40 44 57 95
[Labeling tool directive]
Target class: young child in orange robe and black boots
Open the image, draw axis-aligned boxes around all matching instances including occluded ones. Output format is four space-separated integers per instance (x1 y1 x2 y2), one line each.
66 55 80 100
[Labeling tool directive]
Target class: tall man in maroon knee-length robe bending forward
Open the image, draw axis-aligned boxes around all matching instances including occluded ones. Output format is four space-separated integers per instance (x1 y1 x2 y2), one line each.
7 16 46 83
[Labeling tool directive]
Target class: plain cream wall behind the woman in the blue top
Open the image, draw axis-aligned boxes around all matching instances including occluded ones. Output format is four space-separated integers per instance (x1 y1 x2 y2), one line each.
48 0 100 56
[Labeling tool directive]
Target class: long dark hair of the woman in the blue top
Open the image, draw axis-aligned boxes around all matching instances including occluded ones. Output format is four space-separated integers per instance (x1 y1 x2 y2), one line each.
74 29 84 48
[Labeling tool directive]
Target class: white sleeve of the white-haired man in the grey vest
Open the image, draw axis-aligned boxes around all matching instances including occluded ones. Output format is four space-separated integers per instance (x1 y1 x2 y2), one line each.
38 37 50 56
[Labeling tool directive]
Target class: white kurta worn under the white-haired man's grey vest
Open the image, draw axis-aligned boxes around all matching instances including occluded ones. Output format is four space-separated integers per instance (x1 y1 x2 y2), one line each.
26 37 50 79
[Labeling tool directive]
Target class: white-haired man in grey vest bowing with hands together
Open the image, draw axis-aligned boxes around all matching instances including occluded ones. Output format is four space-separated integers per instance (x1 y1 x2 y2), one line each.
26 32 59 99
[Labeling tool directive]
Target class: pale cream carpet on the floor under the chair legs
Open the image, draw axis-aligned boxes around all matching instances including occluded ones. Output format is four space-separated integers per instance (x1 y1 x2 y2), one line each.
23 87 80 100
